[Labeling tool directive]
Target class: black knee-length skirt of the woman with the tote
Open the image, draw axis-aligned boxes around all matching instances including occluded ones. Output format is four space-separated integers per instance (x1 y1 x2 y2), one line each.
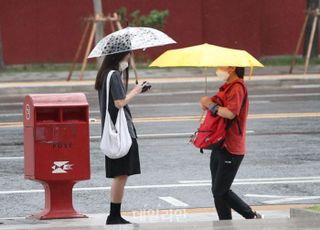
105 138 141 178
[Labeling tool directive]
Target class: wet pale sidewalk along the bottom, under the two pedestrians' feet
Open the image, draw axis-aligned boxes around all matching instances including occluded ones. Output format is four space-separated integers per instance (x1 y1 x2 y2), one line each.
0 204 320 230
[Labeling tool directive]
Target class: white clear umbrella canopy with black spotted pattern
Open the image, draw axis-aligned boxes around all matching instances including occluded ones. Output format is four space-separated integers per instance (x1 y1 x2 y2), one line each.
88 27 176 58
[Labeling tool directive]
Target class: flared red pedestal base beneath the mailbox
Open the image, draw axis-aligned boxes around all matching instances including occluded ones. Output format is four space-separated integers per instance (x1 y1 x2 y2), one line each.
32 181 87 220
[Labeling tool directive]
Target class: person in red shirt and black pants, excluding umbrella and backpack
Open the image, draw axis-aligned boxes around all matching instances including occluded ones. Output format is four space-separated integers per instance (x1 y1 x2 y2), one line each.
200 67 262 220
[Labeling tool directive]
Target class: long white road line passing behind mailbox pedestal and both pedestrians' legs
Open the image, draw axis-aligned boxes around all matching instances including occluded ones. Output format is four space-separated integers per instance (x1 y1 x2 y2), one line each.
0 179 320 195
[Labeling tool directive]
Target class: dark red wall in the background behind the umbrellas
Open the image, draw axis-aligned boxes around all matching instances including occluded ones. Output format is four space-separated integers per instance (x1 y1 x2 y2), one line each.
0 0 306 64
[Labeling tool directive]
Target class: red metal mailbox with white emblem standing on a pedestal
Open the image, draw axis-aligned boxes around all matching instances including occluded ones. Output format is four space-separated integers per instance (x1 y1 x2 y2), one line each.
23 93 90 219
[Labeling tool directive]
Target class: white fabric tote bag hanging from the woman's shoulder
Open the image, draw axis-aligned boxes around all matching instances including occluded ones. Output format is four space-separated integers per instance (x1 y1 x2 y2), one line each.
100 70 132 159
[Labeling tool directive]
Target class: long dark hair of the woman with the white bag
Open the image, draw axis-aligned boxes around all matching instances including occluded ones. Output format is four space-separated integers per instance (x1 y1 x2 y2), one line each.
94 52 130 90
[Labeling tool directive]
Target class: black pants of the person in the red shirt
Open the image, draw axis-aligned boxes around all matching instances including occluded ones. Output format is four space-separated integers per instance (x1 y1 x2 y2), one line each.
210 148 254 220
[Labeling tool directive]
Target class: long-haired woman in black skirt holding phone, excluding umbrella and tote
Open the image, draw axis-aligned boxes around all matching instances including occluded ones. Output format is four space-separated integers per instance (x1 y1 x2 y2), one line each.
95 52 143 224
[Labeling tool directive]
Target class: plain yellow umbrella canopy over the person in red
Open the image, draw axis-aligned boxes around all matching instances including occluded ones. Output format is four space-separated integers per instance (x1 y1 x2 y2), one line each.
149 43 263 68
